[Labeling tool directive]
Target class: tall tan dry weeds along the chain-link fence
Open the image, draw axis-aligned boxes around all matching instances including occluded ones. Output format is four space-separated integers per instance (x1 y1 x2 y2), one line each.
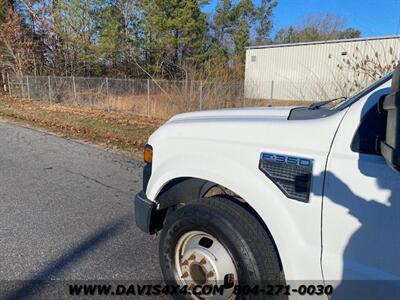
4 76 256 118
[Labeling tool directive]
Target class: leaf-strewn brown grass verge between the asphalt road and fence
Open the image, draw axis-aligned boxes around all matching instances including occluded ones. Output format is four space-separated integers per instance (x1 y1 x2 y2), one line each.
0 96 163 156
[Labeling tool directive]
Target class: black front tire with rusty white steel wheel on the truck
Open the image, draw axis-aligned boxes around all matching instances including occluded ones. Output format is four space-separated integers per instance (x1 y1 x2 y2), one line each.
159 197 285 299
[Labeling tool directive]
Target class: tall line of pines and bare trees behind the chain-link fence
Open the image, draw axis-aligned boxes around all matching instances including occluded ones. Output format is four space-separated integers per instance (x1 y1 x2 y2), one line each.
0 0 360 80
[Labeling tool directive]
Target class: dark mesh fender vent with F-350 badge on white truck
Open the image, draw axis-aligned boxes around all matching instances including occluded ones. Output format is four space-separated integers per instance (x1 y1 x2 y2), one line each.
259 152 314 202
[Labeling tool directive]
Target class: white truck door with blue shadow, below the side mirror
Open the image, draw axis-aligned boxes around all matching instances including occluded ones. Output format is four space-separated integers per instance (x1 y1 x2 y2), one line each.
322 80 400 299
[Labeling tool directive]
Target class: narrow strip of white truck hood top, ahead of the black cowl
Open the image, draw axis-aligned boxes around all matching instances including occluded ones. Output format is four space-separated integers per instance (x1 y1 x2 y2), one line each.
168 106 293 122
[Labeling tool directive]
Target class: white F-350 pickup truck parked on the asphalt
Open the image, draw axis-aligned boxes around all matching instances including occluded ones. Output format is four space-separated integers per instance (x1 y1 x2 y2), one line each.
135 67 400 299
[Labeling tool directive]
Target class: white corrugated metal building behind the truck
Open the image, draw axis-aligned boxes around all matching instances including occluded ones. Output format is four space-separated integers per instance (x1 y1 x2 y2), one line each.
245 36 400 100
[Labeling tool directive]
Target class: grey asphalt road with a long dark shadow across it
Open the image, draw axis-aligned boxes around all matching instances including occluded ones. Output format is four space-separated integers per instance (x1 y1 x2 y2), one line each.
0 122 161 299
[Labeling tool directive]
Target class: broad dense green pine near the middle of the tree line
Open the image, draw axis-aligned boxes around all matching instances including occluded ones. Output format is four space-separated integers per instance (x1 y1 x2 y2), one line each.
144 0 208 77
